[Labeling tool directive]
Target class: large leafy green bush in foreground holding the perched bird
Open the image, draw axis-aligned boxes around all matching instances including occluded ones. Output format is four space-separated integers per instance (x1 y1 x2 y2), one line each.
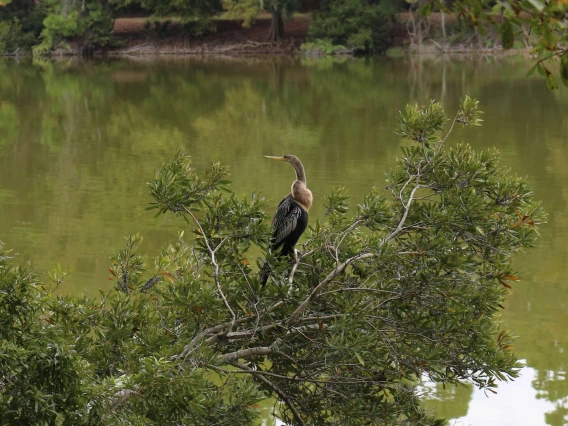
0 98 542 425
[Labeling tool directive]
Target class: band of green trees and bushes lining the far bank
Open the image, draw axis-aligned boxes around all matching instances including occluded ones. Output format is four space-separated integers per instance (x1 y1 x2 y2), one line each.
0 0 568 75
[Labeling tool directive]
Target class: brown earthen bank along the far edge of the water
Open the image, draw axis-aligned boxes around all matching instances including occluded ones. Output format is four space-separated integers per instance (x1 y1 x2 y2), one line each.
1 14 530 58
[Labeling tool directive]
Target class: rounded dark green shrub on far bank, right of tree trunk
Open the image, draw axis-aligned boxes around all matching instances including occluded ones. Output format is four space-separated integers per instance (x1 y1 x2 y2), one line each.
309 0 394 51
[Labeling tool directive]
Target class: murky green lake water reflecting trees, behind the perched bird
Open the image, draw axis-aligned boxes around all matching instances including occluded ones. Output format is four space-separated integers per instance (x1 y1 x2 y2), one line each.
0 57 568 426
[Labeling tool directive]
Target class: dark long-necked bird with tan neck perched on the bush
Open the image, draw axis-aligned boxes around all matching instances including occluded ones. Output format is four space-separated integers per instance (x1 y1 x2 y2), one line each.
260 155 312 287
